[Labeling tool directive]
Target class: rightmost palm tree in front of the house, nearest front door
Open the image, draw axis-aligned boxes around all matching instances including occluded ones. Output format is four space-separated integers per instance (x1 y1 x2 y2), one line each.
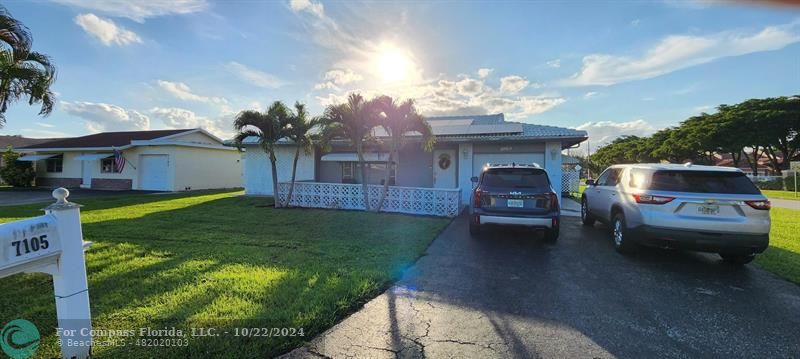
376 96 435 211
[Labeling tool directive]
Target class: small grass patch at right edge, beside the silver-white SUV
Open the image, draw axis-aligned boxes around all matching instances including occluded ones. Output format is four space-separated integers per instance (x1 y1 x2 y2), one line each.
756 208 800 284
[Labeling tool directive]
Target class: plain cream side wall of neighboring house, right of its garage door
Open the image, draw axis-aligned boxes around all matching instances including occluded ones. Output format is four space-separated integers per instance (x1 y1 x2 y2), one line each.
173 147 242 191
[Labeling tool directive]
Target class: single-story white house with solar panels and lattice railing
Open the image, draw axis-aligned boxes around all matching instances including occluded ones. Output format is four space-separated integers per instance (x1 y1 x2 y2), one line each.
239 113 587 214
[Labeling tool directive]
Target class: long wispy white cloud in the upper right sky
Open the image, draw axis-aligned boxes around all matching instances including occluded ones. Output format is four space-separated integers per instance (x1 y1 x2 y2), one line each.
562 22 800 86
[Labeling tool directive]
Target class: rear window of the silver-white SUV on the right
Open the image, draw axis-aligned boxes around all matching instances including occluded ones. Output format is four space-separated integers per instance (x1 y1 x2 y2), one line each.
631 169 761 194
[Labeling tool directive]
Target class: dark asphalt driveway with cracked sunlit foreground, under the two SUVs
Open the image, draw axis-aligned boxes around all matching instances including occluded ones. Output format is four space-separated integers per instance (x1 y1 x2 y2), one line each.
287 216 800 358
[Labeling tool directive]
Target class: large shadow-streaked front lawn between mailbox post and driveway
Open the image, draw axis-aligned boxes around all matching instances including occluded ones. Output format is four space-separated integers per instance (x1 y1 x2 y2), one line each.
0 192 449 358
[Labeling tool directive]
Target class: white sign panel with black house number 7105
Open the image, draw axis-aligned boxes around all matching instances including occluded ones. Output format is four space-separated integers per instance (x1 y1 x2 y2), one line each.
0 214 61 278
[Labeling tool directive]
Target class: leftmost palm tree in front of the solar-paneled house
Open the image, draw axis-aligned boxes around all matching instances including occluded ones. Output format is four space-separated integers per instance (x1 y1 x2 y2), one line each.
233 101 290 207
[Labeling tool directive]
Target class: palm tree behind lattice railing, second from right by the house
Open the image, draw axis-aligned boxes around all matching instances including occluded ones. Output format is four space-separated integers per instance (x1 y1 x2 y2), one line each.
322 93 378 210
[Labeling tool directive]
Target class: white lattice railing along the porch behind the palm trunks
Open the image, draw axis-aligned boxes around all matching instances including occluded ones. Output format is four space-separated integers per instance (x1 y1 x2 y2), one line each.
278 182 461 217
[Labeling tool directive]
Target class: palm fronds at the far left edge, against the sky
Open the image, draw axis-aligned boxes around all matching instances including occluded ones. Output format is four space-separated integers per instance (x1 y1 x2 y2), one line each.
0 6 56 127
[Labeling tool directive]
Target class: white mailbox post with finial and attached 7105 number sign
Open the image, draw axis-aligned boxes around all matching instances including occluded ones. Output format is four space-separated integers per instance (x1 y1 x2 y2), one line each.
0 188 92 359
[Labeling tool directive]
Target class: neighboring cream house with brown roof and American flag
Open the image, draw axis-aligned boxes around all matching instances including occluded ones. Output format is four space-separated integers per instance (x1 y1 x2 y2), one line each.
16 129 242 191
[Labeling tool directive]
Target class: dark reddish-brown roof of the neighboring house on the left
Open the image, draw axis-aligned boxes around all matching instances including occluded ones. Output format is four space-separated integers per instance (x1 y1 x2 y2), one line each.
20 129 193 149
